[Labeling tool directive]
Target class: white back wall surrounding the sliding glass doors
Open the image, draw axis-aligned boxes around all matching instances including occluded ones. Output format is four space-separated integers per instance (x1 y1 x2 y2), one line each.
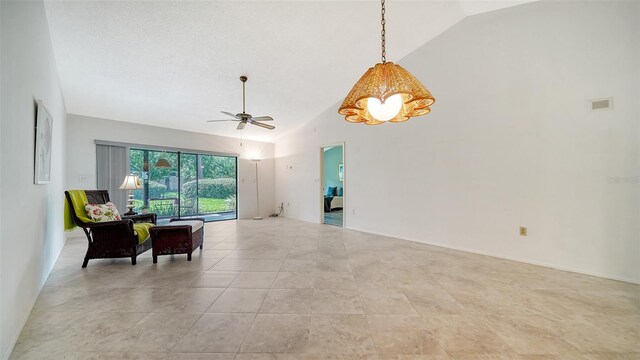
66 114 275 218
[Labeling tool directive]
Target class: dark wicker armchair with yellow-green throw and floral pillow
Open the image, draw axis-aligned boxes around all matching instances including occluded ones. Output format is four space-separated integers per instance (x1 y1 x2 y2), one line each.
65 190 157 268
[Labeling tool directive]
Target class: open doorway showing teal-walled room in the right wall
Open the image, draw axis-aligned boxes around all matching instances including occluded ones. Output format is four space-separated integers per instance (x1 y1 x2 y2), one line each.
320 143 346 227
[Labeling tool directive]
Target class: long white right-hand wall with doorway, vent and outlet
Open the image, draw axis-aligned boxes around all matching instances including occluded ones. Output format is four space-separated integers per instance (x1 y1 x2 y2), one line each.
276 2 640 282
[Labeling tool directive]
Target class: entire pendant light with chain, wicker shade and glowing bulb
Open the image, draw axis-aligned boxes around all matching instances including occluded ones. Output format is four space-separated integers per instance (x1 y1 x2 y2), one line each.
338 0 435 125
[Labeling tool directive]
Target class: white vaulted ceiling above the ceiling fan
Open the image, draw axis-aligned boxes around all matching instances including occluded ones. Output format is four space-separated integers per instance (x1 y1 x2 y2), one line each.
46 0 530 141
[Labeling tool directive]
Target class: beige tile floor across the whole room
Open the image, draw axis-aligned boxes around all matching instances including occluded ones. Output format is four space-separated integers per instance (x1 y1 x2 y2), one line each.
11 219 640 360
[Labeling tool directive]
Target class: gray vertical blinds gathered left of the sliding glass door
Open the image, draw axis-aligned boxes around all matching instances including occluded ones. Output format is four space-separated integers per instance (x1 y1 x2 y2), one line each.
96 145 129 214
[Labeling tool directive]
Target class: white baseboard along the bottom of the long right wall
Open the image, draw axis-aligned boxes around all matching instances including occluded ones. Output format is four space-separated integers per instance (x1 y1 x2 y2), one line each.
345 227 640 285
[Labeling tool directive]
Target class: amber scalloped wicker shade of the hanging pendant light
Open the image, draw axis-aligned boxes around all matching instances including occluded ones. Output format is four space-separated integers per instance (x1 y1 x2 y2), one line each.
338 62 435 125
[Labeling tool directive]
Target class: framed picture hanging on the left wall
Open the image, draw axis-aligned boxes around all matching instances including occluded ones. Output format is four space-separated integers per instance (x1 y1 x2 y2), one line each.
33 100 53 185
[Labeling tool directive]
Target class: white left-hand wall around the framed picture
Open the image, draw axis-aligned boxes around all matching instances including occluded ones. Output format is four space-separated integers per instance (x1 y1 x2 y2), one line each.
0 0 66 358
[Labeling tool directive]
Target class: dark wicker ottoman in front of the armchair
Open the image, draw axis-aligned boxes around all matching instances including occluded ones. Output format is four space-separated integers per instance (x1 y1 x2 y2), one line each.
149 218 204 264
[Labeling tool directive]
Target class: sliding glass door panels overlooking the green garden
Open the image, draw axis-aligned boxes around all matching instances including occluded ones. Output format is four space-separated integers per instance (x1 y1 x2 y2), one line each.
130 148 237 221
